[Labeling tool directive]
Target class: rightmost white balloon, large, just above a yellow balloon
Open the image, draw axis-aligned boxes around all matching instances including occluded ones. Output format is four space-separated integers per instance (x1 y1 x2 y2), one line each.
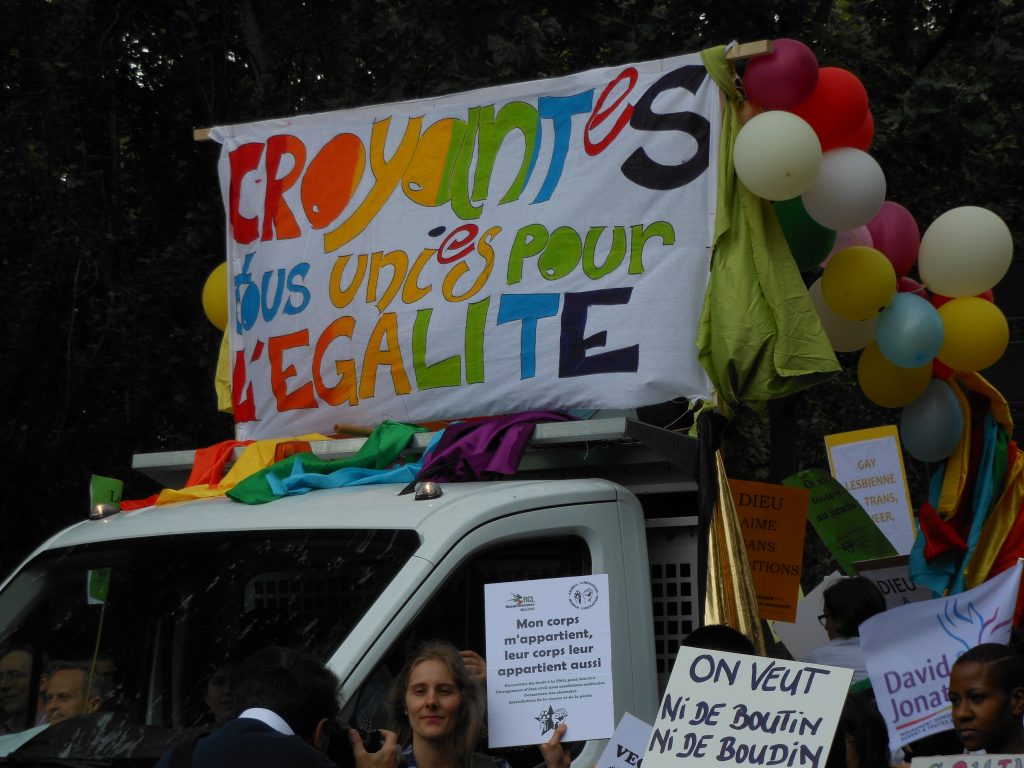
918 206 1014 299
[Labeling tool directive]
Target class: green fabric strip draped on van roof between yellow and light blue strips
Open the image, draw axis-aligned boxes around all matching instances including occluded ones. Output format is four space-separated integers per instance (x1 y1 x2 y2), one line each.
227 421 428 504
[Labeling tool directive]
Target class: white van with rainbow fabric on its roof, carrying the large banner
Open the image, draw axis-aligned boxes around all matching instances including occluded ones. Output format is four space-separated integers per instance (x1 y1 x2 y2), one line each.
0 418 698 768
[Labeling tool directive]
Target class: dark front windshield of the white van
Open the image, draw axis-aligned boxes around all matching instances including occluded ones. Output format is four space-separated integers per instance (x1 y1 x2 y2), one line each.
0 529 419 765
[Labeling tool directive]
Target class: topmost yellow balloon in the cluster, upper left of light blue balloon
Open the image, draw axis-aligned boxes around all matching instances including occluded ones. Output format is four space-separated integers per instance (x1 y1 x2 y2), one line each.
821 246 896 321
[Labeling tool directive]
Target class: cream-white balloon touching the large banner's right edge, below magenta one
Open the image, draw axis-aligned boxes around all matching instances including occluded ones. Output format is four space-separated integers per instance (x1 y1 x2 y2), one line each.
732 111 821 200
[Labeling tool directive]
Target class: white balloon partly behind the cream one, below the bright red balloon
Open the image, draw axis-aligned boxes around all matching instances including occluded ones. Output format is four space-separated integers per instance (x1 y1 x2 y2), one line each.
802 146 886 229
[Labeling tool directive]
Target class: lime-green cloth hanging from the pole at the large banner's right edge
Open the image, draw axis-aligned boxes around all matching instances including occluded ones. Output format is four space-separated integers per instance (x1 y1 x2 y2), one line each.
697 47 841 415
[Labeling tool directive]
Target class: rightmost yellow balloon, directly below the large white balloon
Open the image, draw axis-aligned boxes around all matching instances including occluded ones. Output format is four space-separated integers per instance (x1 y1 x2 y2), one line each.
938 296 1010 371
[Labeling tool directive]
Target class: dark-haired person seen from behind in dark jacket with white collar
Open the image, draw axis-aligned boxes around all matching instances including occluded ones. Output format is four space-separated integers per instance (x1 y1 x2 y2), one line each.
157 646 398 768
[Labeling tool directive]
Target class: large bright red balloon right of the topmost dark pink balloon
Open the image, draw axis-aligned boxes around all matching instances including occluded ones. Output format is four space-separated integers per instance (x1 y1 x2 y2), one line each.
791 67 868 152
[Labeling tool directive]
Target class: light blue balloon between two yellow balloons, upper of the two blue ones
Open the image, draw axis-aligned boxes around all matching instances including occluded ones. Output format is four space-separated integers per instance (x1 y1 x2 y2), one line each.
874 293 944 368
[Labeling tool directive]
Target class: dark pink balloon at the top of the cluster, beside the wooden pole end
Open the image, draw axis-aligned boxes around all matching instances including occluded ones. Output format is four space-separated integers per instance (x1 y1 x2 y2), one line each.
743 38 818 110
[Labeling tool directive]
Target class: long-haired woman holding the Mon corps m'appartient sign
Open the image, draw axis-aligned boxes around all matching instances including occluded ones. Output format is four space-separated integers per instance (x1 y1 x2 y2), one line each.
385 640 569 768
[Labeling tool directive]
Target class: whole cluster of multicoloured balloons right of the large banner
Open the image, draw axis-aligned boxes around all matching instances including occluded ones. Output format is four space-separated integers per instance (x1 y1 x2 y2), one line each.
733 39 1013 462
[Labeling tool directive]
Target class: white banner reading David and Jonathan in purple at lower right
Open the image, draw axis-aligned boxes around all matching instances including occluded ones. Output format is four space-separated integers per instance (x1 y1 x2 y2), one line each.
860 562 1021 750
